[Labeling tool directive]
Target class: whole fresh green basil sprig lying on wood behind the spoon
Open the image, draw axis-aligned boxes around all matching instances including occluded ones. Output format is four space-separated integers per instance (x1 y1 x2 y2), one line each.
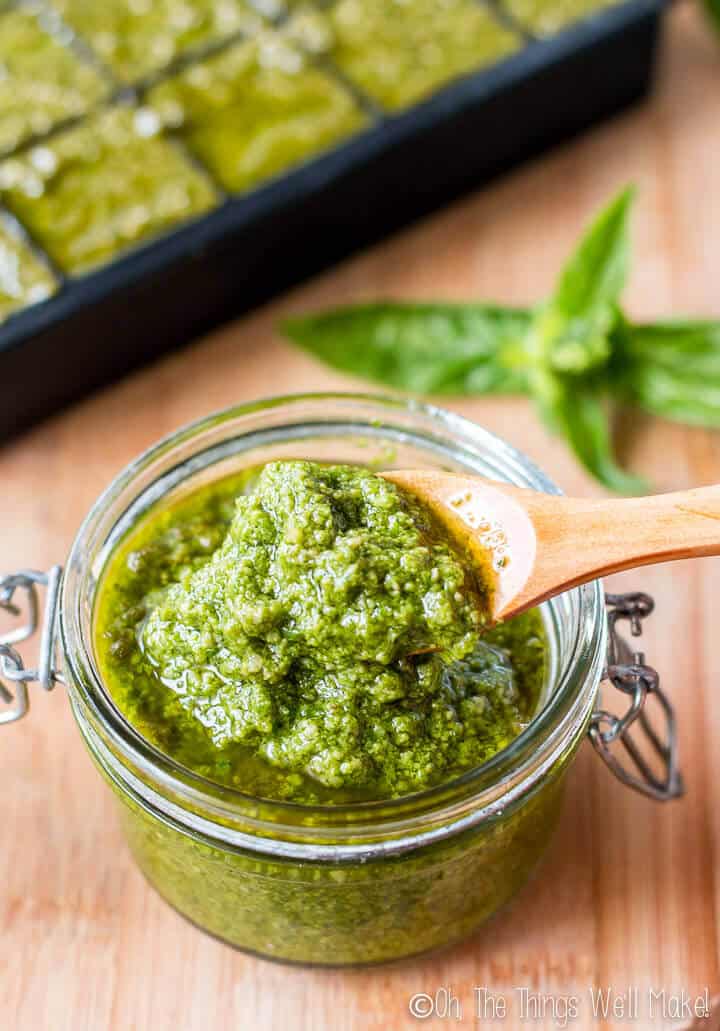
283 193 720 493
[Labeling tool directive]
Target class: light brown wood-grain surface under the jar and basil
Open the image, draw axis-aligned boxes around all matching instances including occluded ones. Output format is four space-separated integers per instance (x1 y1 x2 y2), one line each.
0 0 720 1031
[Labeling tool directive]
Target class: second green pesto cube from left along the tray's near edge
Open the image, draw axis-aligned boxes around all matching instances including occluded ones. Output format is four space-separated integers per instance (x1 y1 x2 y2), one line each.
0 106 216 274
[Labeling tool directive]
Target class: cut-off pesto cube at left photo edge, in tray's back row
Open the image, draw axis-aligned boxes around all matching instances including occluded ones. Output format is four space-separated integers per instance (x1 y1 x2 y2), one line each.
0 8 107 151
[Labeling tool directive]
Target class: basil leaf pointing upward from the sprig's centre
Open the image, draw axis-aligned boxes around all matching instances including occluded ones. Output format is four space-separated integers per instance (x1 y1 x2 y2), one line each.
530 188 634 375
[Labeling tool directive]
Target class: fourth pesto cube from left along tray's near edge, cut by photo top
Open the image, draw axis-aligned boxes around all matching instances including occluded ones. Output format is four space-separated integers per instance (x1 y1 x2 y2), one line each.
321 0 521 110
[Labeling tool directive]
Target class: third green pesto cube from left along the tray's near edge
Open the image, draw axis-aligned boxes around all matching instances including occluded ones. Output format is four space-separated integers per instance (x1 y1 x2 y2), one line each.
150 31 365 192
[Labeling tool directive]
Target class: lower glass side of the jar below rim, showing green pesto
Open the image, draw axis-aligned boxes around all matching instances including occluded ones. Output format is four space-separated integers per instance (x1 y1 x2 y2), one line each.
114 746 565 966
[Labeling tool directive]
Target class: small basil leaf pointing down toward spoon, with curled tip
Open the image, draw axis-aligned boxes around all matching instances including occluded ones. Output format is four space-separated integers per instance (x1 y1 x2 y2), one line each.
543 376 648 494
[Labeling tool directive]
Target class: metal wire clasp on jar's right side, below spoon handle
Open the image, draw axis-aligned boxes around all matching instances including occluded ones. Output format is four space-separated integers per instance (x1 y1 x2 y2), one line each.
588 593 685 802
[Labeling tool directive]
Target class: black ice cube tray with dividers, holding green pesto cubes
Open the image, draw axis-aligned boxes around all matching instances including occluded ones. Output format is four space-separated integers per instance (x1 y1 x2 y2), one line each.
0 0 664 437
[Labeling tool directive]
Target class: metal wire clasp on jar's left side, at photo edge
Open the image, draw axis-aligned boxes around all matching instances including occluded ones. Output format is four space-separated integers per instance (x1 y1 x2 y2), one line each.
0 566 63 724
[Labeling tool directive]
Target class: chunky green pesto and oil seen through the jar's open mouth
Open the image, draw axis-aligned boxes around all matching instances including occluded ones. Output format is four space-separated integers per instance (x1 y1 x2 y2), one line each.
95 462 546 804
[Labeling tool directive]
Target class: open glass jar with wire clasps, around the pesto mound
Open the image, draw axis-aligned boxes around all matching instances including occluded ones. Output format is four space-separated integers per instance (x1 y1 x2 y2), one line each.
0 394 682 965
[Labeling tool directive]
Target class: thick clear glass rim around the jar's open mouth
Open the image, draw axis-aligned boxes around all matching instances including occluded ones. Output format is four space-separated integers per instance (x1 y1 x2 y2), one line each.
59 392 607 856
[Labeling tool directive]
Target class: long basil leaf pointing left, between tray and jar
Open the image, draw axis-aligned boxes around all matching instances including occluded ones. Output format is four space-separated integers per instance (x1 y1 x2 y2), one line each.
283 302 531 395
